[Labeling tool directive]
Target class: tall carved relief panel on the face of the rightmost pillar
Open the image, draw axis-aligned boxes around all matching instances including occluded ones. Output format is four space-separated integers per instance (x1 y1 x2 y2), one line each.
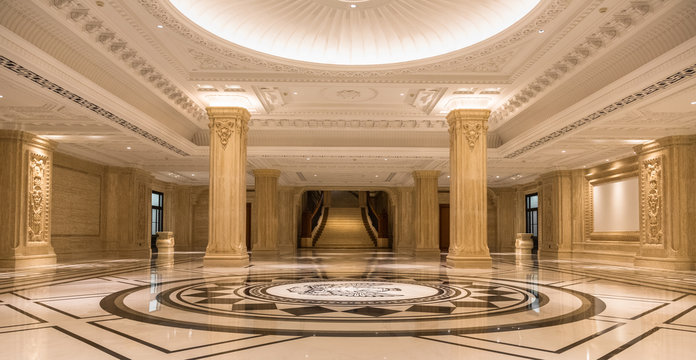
641 158 663 244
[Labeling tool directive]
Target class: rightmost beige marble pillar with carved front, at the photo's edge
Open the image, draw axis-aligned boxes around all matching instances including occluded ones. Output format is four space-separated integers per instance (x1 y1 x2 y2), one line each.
635 135 696 270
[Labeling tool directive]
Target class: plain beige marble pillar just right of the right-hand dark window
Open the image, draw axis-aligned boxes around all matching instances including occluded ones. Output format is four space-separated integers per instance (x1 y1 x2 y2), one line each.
539 170 573 258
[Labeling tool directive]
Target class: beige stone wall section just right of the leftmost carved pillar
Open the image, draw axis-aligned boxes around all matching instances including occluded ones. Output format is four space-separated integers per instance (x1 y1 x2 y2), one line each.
51 153 104 260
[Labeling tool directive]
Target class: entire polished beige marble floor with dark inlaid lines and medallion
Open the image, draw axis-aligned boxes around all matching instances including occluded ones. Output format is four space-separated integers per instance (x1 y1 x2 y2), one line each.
0 250 696 360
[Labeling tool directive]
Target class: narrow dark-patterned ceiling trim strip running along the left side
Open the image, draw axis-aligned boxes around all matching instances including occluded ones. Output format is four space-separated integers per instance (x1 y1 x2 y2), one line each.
0 55 190 156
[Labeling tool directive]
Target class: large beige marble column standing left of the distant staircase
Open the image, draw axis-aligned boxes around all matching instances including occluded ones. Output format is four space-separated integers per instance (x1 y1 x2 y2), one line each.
203 107 251 266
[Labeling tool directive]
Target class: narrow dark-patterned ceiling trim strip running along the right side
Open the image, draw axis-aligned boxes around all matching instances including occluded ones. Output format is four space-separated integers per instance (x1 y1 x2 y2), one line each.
504 64 696 159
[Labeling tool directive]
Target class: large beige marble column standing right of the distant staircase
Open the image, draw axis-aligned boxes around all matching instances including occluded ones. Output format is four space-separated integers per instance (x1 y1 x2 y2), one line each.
447 109 491 267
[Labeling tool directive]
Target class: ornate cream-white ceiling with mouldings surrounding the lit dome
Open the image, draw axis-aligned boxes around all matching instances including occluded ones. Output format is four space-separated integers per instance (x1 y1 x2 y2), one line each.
0 0 696 186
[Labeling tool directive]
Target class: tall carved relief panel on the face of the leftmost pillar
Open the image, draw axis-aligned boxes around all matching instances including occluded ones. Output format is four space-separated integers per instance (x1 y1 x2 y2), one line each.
27 153 49 242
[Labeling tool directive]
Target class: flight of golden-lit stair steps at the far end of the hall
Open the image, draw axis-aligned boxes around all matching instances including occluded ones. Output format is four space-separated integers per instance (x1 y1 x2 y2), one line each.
314 207 375 249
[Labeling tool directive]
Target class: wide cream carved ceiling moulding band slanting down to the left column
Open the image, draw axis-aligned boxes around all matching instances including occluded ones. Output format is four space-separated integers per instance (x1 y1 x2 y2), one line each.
44 0 208 122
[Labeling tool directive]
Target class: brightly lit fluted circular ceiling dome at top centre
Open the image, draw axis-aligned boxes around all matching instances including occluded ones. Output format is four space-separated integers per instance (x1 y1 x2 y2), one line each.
169 0 540 65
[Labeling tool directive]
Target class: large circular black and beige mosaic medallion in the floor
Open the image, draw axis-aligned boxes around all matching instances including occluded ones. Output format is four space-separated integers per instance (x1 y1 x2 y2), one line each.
101 274 604 336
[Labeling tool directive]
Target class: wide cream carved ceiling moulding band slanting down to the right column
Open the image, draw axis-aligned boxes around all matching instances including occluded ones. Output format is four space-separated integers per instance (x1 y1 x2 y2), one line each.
489 0 668 127
